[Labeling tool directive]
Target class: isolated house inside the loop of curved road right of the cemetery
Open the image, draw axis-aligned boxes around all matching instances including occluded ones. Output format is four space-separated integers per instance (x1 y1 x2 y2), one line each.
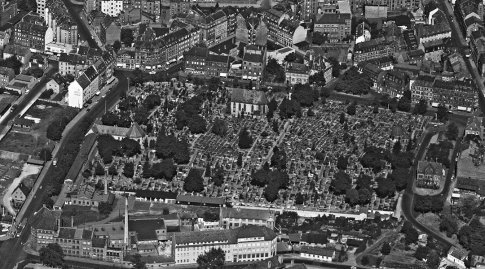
416 161 445 189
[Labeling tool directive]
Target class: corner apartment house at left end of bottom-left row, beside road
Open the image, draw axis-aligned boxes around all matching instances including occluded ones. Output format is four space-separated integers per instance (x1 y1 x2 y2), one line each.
30 207 61 251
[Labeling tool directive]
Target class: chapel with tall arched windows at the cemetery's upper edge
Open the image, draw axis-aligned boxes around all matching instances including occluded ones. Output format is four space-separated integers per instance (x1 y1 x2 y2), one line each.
231 88 268 117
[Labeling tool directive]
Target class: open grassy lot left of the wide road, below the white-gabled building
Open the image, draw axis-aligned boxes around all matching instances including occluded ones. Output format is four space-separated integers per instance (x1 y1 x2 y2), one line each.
0 106 63 156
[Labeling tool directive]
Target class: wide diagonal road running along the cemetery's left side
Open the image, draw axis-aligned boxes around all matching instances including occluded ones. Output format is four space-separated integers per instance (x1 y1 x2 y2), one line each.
0 72 128 269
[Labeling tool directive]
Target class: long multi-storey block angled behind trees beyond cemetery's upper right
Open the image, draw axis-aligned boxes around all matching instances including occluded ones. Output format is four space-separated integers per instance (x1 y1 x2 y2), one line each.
354 38 397 64
